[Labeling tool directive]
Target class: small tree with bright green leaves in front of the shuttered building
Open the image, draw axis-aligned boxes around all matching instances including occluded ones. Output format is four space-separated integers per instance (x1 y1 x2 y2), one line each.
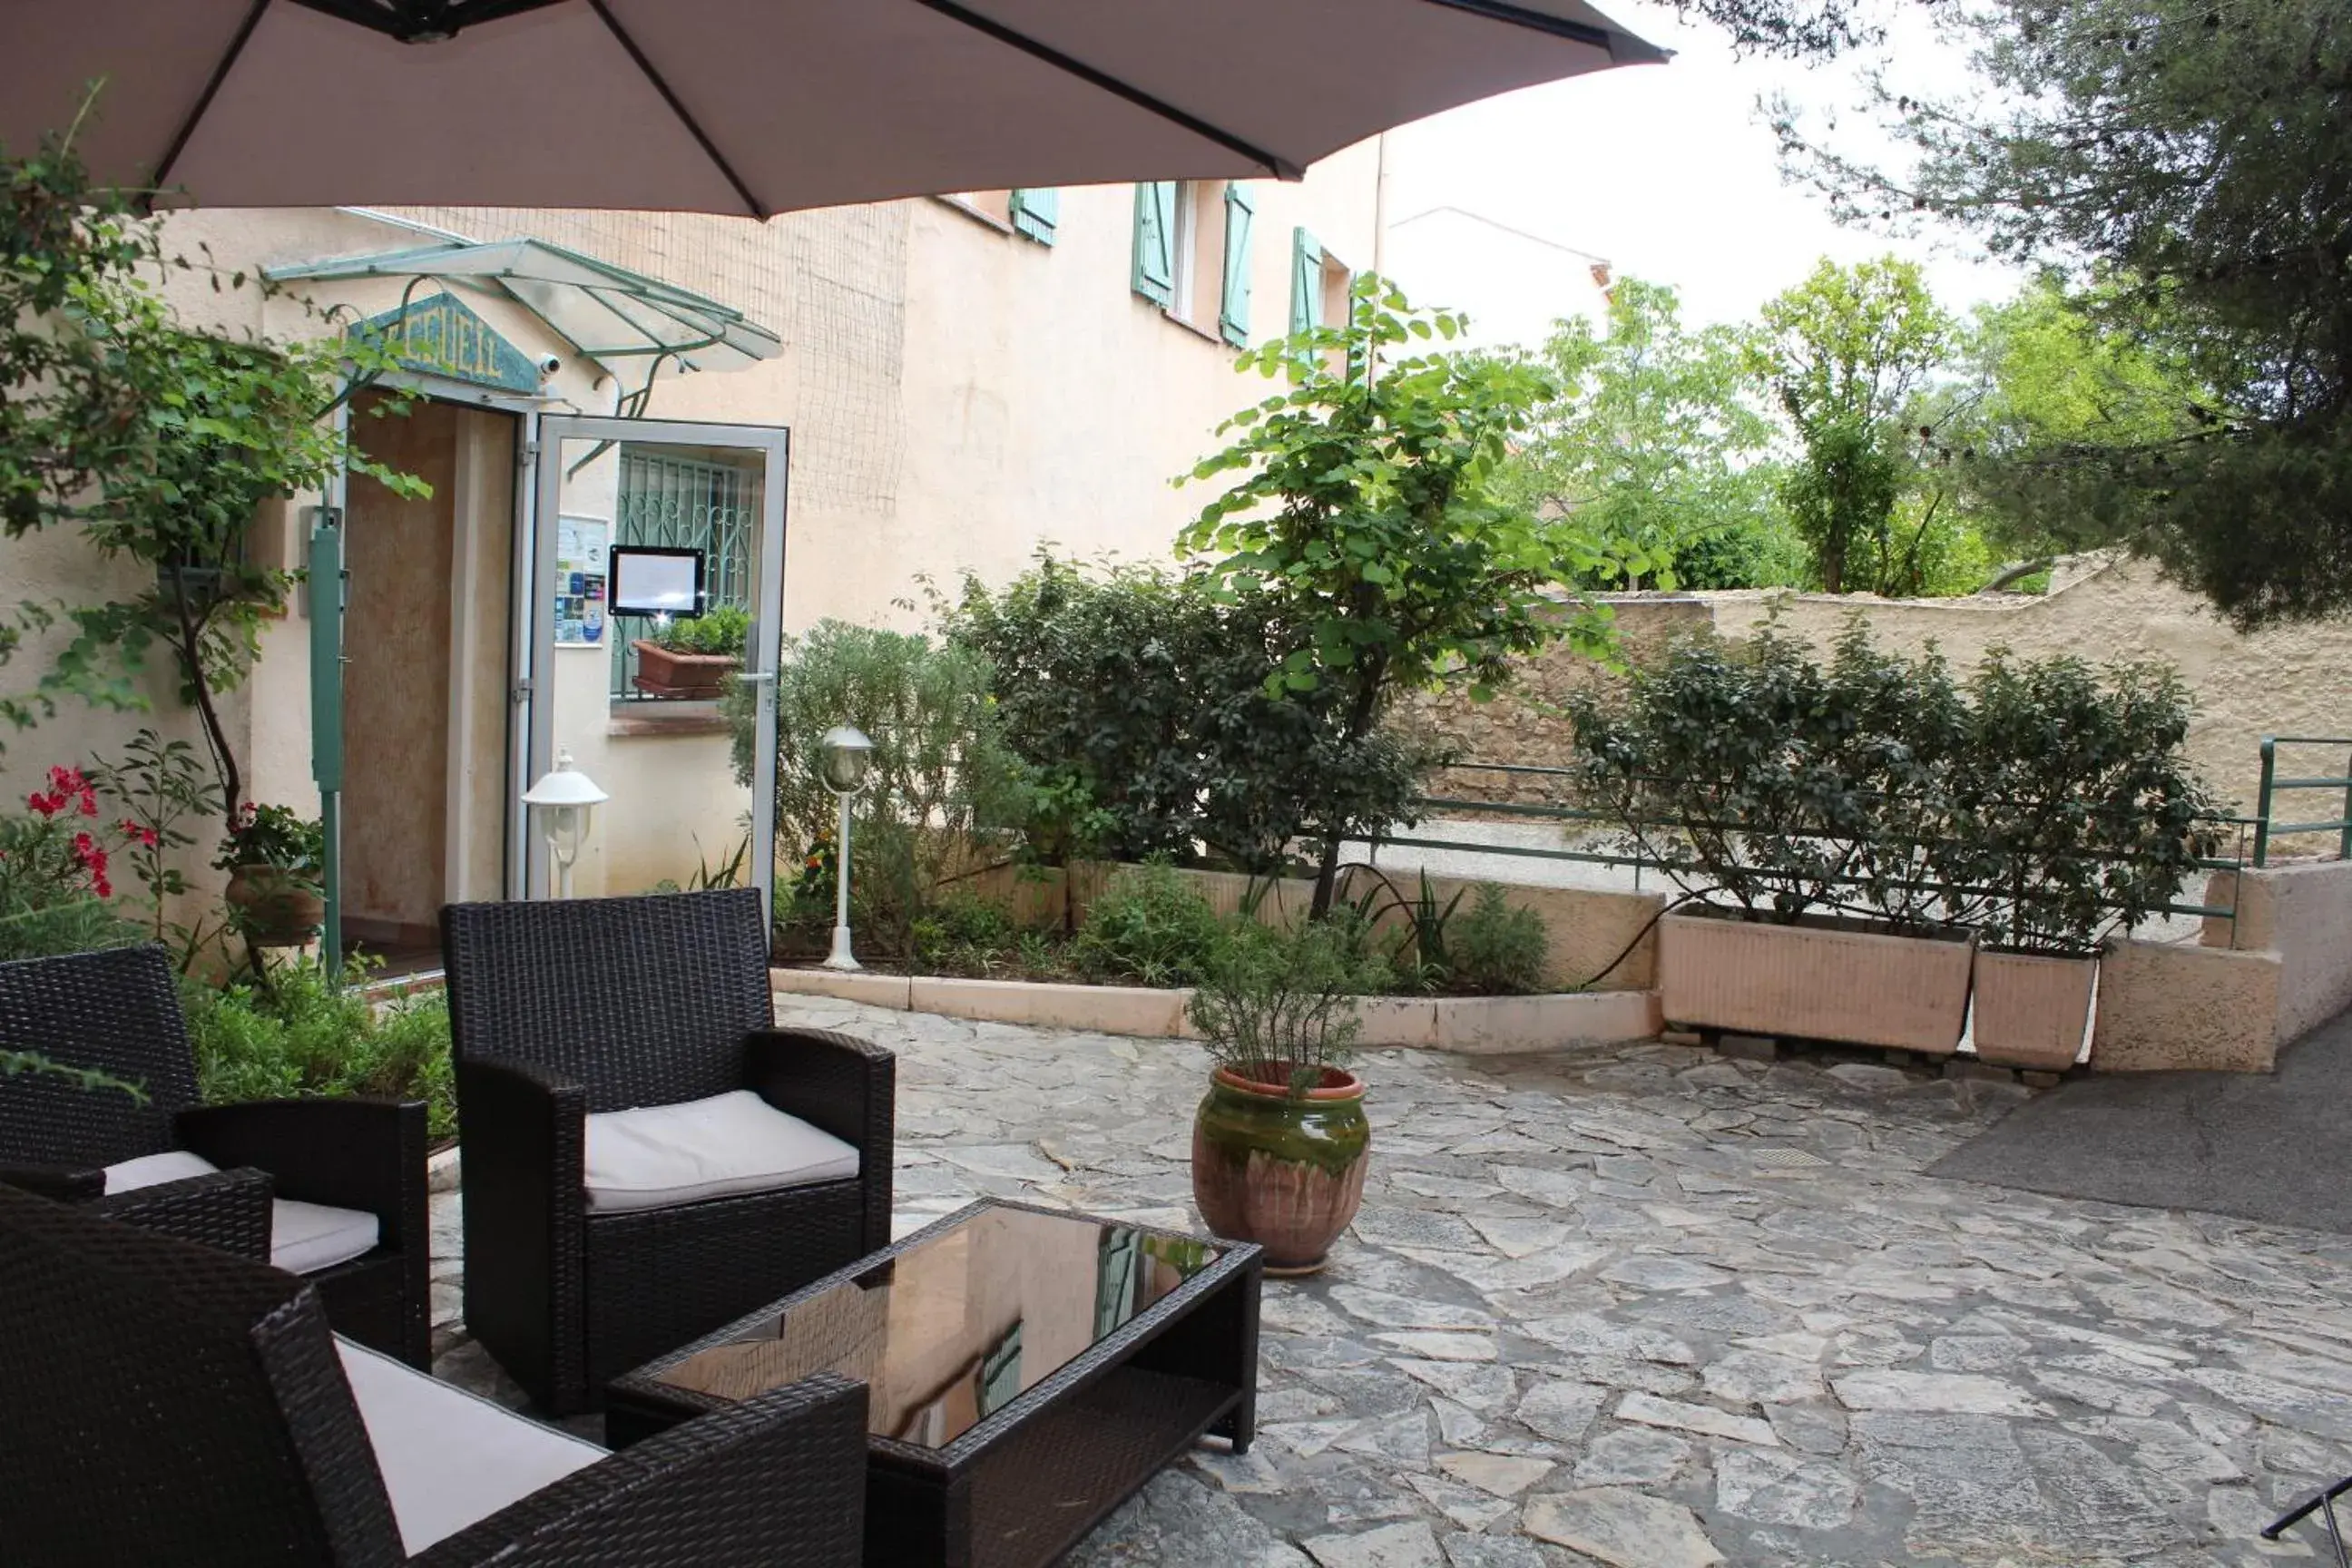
1179 275 1622 915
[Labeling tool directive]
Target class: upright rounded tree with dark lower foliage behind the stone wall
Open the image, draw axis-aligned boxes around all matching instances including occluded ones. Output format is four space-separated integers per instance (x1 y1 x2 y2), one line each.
1752 256 1955 593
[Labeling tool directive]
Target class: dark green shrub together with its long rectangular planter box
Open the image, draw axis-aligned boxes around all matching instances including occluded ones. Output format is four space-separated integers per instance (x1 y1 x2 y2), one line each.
1569 618 1971 1055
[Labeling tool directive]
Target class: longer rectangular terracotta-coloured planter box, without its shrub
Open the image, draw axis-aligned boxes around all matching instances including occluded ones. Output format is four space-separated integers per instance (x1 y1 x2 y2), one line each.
1658 915 1974 1055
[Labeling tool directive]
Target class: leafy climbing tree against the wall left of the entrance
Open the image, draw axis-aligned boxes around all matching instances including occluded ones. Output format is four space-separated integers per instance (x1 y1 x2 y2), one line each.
0 116 430 825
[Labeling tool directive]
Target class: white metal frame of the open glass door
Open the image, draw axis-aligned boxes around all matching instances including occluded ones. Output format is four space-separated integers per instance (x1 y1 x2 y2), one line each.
529 414 793 907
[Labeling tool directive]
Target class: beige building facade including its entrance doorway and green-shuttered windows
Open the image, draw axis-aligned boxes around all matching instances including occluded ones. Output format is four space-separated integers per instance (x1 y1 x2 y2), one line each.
0 143 1381 950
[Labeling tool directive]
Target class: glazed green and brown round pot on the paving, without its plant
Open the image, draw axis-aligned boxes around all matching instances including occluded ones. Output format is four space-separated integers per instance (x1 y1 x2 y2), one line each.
1192 1067 1371 1274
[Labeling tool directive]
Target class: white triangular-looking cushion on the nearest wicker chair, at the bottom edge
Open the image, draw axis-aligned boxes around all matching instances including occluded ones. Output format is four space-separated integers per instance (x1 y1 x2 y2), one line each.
334 1336 604 1556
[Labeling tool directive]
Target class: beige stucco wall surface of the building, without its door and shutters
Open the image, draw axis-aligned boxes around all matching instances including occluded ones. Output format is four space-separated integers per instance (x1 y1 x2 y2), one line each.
0 146 1378 912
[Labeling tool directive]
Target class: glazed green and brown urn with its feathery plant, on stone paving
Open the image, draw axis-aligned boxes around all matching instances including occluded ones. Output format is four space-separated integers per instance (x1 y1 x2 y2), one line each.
1188 916 1378 1274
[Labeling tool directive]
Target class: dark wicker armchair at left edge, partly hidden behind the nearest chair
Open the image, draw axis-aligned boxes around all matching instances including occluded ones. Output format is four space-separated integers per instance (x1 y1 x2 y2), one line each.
0 947 433 1366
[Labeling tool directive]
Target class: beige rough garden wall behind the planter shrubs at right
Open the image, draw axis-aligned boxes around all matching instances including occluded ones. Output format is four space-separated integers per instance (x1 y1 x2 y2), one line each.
1421 560 2352 832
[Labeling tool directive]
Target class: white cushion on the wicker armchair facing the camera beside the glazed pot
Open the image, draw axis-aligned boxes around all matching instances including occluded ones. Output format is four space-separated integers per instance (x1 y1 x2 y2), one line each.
588 1088 858 1213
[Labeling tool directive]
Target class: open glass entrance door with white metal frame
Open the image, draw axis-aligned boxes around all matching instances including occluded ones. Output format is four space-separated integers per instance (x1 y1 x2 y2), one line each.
513 416 788 907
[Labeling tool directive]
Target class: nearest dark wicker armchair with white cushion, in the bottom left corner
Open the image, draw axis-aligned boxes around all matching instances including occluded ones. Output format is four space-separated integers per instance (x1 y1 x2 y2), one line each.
0 1190 866 1568
